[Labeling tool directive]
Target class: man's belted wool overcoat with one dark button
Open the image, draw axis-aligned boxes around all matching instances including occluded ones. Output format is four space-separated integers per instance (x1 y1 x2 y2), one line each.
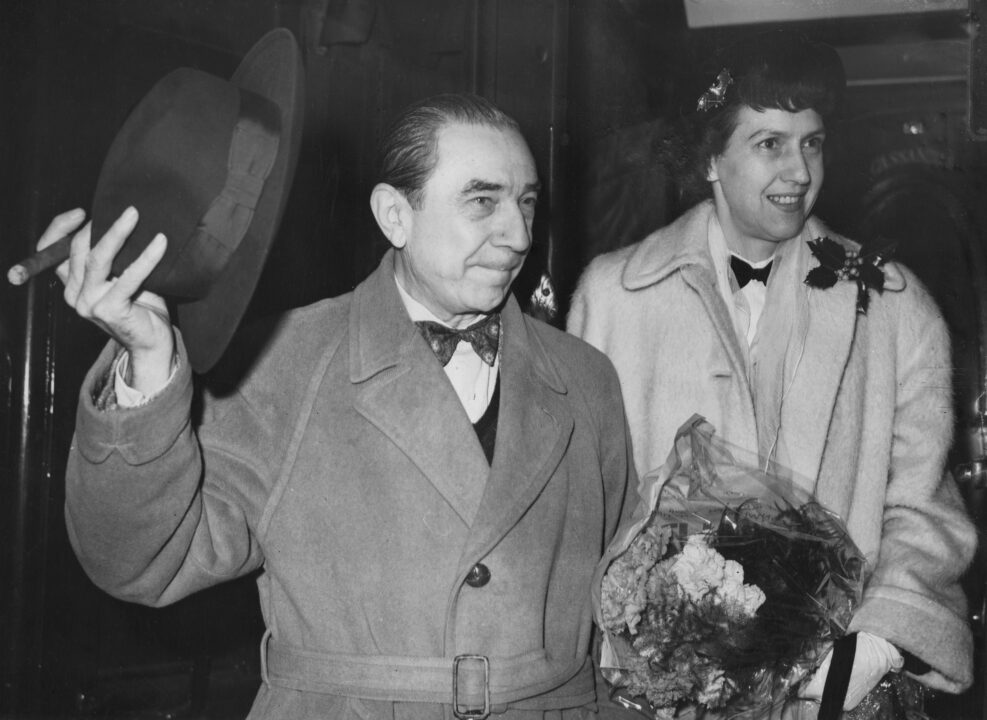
66 251 633 720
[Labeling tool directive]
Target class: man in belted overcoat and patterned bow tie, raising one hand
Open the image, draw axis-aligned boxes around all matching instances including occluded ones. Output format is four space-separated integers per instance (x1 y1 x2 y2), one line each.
40 95 633 720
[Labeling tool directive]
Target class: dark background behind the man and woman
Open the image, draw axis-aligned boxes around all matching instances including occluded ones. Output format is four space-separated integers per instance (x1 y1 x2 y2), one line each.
0 0 987 720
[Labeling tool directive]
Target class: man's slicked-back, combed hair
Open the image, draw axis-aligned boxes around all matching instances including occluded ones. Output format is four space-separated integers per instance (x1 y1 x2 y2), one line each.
377 93 521 208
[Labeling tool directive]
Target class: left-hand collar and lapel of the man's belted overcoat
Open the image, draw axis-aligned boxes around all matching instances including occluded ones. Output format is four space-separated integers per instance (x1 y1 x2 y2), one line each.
350 251 490 525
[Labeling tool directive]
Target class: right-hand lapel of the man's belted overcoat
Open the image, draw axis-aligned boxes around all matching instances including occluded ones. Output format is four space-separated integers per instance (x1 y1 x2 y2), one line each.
462 297 573 572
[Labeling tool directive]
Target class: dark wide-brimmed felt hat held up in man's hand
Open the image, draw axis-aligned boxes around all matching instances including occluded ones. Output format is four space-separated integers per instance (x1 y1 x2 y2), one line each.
92 28 305 373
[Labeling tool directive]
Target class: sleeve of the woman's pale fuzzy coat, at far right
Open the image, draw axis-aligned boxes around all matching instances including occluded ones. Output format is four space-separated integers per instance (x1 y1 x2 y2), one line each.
851 277 977 692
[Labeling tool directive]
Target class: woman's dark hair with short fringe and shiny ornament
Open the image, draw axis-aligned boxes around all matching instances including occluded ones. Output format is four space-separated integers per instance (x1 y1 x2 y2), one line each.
660 30 846 205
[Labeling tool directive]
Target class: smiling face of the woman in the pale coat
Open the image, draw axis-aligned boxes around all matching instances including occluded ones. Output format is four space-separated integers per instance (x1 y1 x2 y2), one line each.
707 106 826 261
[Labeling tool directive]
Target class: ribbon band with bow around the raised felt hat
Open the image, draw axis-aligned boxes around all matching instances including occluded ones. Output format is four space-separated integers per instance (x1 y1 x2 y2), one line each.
164 88 281 299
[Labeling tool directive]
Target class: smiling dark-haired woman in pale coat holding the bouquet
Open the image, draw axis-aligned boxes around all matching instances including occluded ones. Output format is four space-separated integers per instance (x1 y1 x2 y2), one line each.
568 32 976 709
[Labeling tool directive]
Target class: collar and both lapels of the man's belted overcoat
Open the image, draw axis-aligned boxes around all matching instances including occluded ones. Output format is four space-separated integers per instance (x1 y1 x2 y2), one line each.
349 250 573 544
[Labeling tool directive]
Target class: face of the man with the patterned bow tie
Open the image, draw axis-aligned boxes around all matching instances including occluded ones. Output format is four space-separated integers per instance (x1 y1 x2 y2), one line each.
397 124 539 326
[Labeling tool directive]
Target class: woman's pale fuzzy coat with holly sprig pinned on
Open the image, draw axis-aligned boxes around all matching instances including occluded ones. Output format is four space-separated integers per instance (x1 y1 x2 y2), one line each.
568 202 976 692
